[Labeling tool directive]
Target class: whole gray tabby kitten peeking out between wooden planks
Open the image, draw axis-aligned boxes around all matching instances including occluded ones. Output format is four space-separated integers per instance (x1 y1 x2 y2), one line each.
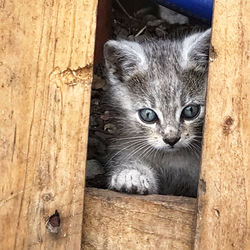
104 29 211 196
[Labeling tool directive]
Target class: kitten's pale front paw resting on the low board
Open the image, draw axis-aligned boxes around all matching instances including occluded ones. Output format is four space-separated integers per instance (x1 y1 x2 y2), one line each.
110 169 157 194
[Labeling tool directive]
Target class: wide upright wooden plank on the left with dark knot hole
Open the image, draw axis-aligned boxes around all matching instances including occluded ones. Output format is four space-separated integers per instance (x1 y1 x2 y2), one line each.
0 0 97 250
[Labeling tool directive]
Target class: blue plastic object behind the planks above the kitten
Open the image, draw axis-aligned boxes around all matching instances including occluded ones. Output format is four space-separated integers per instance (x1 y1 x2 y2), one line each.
154 0 213 23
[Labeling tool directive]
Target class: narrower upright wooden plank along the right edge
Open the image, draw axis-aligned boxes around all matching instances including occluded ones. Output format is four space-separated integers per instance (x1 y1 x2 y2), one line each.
195 0 250 250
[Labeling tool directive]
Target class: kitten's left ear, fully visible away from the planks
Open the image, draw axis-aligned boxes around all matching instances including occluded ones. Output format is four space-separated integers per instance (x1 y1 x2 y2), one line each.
104 40 147 78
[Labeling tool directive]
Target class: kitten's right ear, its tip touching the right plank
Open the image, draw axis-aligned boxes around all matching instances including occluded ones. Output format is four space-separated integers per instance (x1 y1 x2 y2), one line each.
181 29 211 72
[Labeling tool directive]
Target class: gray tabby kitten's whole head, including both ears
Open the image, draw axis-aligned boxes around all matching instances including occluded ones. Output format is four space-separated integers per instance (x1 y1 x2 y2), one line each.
105 31 210 151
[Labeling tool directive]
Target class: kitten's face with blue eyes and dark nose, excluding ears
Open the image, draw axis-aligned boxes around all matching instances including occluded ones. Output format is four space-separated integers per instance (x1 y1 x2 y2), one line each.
124 70 205 151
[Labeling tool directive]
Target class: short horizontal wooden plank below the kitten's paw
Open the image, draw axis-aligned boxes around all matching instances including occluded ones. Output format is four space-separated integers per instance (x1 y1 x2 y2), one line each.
83 188 196 250
